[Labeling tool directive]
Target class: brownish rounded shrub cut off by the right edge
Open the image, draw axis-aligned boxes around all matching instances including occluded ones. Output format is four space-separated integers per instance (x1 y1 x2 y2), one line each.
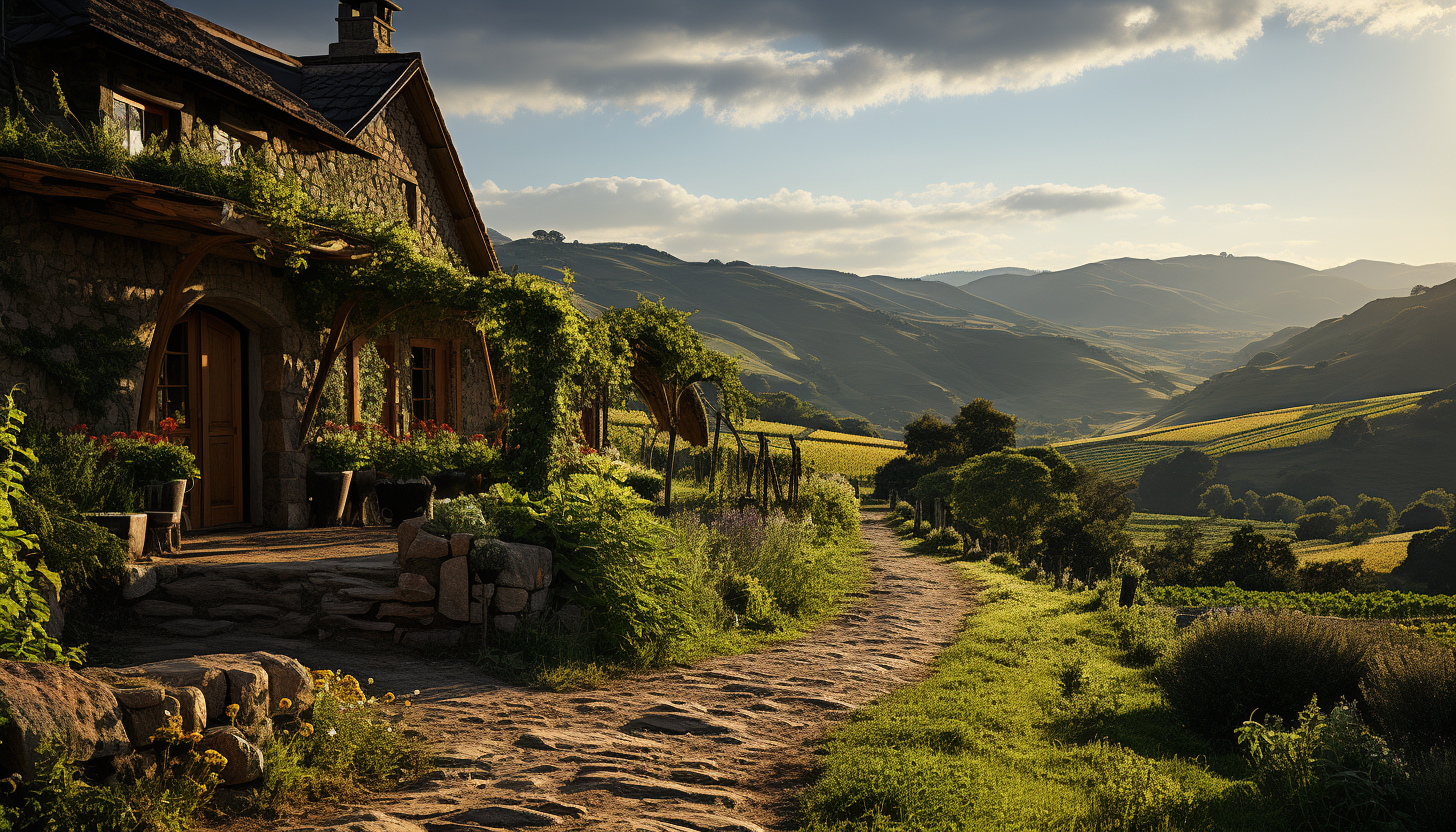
1360 641 1456 752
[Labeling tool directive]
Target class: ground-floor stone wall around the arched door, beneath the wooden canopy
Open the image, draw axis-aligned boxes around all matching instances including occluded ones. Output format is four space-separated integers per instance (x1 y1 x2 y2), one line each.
0 191 322 527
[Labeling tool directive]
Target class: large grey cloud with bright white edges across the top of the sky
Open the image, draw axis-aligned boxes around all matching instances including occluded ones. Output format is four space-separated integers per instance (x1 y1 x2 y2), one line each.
416 0 1456 125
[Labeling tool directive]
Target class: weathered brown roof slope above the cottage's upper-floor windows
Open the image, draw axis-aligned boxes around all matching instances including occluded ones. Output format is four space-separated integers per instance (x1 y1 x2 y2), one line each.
9 0 354 147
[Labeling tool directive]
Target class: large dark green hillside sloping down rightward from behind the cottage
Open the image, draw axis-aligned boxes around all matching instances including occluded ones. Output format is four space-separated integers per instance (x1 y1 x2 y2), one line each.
496 240 1178 431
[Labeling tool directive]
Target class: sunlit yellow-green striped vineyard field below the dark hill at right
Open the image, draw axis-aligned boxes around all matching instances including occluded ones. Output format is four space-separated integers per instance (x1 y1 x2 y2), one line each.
1053 392 1425 479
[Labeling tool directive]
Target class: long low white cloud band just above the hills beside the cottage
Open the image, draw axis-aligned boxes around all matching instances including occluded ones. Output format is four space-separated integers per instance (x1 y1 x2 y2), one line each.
476 176 1160 275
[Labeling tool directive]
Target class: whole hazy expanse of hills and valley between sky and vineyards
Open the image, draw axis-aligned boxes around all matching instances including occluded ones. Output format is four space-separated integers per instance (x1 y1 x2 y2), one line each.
495 236 1456 436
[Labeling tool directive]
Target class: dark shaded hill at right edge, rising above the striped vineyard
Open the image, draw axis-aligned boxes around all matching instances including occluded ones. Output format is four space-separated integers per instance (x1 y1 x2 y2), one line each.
1147 280 1456 427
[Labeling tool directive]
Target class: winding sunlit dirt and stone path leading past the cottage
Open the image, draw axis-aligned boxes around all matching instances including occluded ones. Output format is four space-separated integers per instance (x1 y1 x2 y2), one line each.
182 513 970 832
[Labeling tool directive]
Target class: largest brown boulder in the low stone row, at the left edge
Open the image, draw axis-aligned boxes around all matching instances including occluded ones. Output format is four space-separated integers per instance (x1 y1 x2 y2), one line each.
0 660 131 778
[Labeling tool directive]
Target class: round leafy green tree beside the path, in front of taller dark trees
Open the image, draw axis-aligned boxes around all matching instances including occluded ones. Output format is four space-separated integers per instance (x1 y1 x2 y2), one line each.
951 450 1076 554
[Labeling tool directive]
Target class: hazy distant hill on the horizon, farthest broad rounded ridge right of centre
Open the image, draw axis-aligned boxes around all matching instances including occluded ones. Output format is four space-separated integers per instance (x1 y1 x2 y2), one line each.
965 255 1382 332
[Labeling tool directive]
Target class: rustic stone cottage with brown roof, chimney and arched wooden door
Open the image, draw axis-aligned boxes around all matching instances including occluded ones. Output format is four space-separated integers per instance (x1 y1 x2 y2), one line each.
0 0 499 527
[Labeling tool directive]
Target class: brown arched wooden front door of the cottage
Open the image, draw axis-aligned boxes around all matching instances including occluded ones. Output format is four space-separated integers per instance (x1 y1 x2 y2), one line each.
157 309 246 527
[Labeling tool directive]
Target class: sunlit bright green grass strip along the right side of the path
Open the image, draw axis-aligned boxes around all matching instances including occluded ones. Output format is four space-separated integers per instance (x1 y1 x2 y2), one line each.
802 553 1262 832
